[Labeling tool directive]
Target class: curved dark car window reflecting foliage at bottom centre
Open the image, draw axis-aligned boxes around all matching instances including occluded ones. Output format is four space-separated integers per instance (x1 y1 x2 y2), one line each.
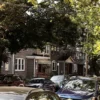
26 91 60 100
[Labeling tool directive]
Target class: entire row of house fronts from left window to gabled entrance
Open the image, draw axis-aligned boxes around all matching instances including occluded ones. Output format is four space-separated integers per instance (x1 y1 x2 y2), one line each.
2 45 84 78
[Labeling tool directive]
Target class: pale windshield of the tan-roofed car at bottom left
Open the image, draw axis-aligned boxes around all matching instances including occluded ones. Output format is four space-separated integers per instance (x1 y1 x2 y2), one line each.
0 93 25 100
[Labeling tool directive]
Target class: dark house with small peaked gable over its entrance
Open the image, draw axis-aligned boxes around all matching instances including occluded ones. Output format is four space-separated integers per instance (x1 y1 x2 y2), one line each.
51 48 85 75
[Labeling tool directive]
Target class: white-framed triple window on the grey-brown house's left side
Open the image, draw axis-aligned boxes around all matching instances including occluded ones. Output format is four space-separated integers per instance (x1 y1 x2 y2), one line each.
15 58 25 71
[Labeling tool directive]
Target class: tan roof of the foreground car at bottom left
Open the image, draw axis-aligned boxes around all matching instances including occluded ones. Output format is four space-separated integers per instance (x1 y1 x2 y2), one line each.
0 86 44 94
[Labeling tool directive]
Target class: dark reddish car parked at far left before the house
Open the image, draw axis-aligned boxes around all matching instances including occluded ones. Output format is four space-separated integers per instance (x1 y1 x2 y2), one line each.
0 74 25 86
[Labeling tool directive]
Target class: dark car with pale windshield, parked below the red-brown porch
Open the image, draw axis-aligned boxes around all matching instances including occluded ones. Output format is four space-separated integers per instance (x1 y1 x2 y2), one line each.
25 78 59 91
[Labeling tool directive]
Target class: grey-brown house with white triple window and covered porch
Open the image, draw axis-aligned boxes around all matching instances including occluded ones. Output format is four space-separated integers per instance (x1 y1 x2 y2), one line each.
1 45 51 78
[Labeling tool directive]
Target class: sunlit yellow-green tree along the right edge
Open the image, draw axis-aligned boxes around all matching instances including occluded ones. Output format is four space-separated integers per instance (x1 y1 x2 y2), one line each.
65 0 100 73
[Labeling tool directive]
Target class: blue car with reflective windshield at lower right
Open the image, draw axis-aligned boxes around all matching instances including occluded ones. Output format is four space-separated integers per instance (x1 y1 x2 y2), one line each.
56 76 99 100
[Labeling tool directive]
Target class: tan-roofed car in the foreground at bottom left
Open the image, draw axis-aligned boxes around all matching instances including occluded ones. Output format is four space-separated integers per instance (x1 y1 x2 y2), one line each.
0 86 60 100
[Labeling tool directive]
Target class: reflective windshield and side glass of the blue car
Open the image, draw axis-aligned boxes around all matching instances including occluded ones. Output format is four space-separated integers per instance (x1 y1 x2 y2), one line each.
64 79 95 91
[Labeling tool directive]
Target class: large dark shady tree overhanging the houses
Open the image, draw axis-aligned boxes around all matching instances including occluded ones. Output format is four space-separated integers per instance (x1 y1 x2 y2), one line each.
0 0 79 72
